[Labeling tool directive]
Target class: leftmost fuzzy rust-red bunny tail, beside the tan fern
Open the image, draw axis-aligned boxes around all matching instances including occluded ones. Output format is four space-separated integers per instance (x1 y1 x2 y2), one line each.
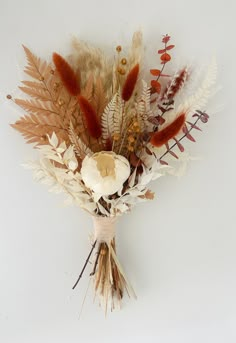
52 52 80 96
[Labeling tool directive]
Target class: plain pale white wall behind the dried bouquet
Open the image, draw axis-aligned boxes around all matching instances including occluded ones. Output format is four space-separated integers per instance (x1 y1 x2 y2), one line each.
0 0 236 343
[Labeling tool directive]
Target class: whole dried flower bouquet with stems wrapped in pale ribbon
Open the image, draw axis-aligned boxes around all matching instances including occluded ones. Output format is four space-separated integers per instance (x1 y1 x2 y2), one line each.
8 32 217 310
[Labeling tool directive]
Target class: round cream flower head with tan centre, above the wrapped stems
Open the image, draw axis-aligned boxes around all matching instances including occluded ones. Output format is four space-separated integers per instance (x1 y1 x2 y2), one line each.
80 151 130 196
